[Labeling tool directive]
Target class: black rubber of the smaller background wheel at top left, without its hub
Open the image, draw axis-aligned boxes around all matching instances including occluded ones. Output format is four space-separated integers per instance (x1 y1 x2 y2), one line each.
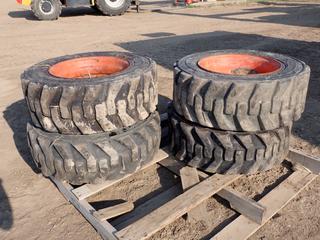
31 0 62 20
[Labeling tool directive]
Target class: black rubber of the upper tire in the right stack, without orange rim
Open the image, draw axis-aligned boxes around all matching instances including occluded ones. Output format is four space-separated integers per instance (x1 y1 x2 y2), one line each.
173 50 310 131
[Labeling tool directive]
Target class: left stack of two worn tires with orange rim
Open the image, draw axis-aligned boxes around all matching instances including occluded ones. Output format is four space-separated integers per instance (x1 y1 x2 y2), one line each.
21 52 161 185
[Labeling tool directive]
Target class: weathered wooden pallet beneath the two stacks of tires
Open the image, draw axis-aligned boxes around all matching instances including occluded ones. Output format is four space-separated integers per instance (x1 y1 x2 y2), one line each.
51 115 320 240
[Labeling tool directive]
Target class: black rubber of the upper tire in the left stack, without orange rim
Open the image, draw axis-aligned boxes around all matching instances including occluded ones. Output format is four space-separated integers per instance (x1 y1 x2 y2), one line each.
21 52 158 134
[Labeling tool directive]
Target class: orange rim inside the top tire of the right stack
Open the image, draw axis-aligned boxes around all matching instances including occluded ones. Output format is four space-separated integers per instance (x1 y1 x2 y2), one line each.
198 53 281 76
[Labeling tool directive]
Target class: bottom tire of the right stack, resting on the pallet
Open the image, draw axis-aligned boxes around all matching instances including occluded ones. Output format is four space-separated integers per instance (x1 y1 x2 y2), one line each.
171 110 290 174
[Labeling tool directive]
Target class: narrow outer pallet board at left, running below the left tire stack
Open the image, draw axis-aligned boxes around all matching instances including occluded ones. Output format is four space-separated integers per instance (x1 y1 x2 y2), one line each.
50 177 117 240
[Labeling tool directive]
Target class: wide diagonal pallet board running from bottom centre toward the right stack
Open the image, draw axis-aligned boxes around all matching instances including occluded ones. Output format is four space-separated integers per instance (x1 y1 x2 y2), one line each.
115 174 240 240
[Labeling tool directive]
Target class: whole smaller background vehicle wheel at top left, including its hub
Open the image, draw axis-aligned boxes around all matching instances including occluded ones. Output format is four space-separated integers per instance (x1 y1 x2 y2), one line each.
31 0 62 20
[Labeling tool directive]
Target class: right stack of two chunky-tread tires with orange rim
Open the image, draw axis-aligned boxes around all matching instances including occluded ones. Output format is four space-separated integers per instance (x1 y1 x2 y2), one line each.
171 50 310 174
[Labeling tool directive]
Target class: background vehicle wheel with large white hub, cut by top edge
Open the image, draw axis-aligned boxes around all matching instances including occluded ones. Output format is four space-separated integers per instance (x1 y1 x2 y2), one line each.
96 0 131 16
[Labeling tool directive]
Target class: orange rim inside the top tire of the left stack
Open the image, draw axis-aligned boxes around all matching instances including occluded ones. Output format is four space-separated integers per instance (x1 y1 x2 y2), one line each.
49 56 130 79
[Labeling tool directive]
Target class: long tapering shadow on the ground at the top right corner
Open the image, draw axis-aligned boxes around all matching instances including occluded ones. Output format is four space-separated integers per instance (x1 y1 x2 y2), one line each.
157 1 320 27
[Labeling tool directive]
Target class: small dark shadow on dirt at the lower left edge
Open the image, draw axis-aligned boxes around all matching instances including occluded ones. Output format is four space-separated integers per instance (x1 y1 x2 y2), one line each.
0 178 13 230
